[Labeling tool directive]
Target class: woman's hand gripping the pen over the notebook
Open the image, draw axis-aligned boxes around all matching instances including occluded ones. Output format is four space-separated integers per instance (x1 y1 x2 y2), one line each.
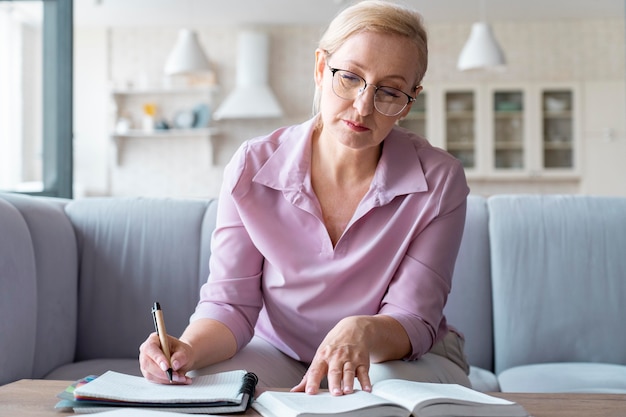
139 332 193 384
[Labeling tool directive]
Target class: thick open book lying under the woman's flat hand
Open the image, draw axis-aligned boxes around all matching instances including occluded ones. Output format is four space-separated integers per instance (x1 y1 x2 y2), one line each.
252 379 528 417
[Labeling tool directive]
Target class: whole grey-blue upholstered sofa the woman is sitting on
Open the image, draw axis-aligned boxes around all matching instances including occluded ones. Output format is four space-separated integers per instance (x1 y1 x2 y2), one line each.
0 193 626 393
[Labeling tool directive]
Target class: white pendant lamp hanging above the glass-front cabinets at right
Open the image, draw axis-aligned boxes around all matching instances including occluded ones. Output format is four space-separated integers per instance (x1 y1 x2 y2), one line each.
457 0 506 71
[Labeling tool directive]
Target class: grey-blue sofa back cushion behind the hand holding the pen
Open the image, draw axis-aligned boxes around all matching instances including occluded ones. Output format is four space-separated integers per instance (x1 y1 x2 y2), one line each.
66 197 215 360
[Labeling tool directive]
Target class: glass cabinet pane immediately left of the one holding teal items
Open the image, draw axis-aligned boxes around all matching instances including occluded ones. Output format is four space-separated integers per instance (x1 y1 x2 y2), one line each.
445 91 476 169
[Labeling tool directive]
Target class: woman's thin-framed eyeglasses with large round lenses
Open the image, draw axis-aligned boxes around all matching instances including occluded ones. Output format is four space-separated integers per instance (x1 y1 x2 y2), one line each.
328 66 415 116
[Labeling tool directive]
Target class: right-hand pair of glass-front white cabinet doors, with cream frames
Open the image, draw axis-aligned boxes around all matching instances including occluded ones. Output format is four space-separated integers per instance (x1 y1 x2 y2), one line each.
482 84 581 178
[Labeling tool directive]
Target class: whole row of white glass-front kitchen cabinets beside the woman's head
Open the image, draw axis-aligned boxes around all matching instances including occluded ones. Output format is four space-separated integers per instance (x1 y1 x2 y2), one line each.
401 83 581 181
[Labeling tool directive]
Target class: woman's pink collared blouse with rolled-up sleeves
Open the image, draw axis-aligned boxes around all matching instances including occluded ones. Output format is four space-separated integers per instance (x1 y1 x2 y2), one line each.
191 118 469 362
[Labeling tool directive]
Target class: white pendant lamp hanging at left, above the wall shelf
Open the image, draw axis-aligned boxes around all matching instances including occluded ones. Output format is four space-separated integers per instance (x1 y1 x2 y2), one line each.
164 29 211 75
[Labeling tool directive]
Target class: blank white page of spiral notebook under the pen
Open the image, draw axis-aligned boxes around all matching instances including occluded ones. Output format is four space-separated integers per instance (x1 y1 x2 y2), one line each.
74 370 246 404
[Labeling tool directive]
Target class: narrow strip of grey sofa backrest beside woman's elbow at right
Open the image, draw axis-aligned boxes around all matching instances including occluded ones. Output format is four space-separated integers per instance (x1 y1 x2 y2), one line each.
444 195 493 370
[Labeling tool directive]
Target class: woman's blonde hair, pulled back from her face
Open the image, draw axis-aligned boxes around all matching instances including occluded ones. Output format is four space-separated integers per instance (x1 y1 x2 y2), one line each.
313 0 428 113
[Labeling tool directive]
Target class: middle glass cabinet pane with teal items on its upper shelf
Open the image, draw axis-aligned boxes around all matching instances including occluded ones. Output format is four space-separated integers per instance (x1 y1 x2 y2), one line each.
492 90 526 170
